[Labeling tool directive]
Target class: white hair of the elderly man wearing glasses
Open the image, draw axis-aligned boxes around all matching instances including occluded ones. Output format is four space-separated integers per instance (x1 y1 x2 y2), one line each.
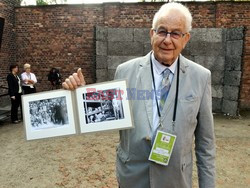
152 2 192 32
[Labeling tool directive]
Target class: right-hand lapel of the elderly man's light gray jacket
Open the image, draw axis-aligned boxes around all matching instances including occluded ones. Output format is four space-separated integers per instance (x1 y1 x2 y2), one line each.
162 55 187 119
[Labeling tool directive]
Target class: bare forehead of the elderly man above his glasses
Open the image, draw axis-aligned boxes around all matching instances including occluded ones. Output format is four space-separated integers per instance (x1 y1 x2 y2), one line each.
156 9 186 31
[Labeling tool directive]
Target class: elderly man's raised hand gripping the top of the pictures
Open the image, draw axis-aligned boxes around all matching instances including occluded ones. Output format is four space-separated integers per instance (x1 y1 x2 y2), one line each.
62 68 86 90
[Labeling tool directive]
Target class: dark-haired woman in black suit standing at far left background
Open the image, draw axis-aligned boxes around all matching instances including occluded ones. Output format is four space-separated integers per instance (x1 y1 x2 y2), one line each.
7 64 22 124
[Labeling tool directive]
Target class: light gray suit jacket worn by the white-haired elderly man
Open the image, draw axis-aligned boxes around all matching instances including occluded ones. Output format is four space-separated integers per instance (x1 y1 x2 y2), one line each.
115 54 215 188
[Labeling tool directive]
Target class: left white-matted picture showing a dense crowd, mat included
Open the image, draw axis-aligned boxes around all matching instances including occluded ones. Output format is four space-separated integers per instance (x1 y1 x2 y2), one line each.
22 89 76 140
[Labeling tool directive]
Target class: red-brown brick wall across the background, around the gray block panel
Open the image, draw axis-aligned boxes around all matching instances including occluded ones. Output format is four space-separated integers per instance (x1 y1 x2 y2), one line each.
4 2 250 108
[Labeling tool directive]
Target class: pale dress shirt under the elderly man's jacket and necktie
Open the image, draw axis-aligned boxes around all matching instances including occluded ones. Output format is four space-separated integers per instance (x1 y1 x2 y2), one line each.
151 53 178 135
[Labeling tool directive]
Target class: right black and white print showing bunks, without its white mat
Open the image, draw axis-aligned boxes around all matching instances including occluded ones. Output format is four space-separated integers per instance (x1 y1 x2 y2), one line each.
83 88 124 124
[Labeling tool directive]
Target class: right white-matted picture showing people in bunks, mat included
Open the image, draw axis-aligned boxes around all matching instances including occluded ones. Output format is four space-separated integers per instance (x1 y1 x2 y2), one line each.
76 80 133 133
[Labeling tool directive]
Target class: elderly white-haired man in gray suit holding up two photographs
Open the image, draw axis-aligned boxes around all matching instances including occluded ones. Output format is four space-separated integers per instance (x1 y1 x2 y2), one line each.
63 3 215 188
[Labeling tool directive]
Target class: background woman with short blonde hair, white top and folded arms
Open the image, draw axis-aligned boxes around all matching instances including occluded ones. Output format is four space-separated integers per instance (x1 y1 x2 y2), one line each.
21 63 37 94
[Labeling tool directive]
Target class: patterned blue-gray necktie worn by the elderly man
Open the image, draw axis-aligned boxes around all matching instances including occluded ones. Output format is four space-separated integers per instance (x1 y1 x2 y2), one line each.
159 68 171 111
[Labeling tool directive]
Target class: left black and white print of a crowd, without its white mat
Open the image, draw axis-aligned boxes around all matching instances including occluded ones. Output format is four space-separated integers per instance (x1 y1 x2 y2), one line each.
29 97 69 130
